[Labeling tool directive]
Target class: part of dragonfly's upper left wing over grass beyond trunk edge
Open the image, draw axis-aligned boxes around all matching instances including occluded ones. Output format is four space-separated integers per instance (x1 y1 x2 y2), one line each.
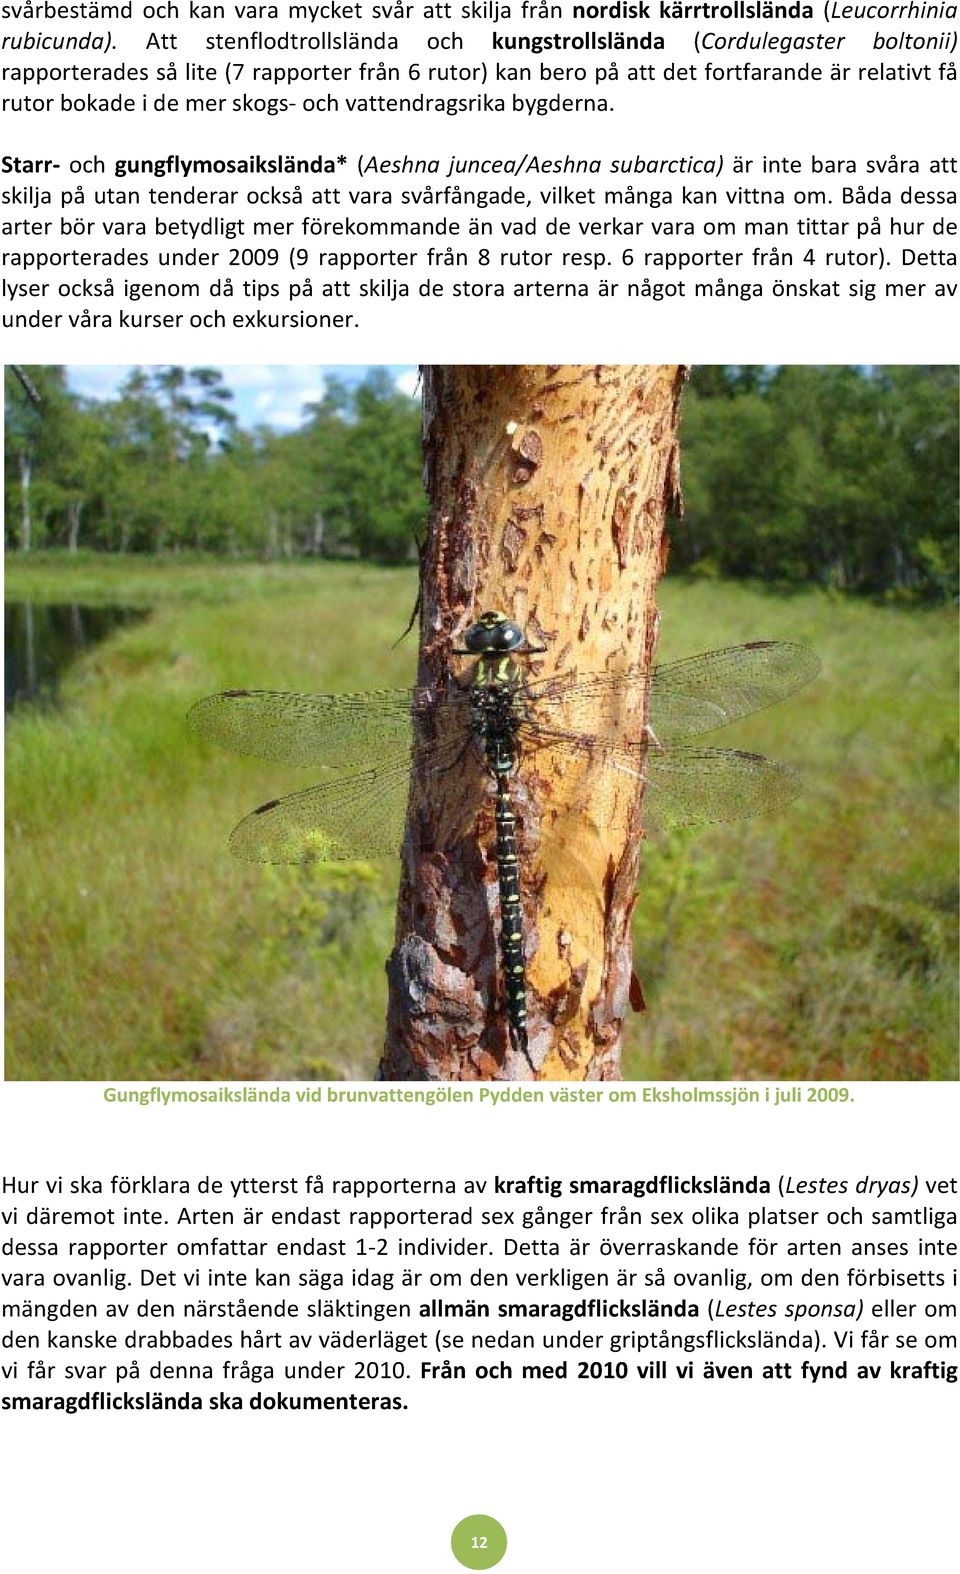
187 689 417 767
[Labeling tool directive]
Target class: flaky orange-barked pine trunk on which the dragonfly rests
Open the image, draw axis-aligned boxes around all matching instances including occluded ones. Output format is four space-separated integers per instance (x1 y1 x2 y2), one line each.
379 367 685 1080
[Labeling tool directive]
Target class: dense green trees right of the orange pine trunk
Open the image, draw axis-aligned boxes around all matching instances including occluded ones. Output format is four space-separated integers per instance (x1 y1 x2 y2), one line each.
674 367 957 598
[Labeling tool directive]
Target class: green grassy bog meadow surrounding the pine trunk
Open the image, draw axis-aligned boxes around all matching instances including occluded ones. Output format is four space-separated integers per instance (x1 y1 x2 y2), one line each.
6 557 957 1078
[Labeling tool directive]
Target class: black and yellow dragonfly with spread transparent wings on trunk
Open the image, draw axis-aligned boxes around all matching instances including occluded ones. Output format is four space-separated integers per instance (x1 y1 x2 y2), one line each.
187 611 820 1053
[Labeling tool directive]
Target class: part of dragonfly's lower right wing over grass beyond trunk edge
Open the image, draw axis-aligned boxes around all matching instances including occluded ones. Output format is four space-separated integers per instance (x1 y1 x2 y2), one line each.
644 749 801 826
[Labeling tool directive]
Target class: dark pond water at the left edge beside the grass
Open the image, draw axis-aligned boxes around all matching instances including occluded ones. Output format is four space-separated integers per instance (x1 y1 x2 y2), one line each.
3 601 146 711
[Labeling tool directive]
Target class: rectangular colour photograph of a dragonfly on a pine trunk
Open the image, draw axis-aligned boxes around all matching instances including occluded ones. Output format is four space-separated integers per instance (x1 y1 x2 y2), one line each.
5 364 958 1083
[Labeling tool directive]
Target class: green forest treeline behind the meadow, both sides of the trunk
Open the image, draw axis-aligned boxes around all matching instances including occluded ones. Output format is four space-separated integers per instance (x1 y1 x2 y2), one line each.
5 367 958 598
